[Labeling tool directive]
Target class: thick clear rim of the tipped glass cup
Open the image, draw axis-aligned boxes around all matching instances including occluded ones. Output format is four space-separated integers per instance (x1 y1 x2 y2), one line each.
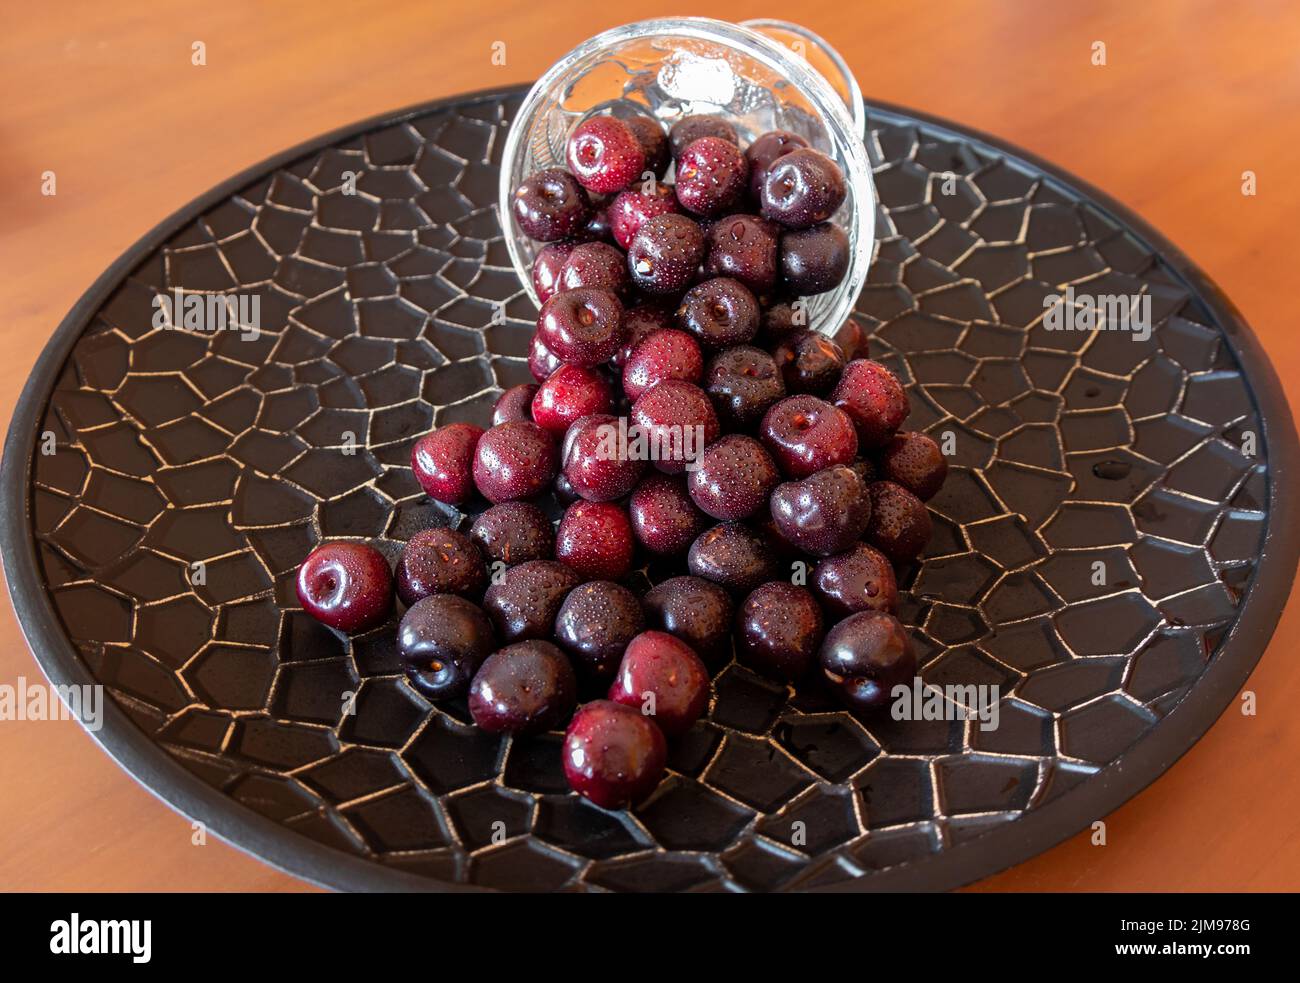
497 17 876 334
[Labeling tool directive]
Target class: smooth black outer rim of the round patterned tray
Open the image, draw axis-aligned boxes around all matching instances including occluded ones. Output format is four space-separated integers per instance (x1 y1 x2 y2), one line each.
0 83 1300 893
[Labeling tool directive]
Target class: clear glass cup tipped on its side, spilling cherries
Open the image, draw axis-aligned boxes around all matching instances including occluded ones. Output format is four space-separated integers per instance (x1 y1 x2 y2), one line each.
498 17 876 334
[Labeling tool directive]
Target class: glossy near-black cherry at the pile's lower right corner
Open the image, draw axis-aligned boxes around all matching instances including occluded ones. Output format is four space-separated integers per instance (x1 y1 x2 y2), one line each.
818 611 917 710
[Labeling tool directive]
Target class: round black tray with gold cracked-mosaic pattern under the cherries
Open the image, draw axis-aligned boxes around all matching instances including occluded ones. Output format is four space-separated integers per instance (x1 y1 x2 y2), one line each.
3 90 1300 891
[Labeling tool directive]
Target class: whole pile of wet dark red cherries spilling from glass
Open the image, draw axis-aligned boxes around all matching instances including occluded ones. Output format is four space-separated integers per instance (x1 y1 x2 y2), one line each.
298 116 948 809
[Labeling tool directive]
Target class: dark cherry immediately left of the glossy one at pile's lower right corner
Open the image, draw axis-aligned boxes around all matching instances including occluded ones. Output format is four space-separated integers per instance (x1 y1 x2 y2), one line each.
736 580 823 681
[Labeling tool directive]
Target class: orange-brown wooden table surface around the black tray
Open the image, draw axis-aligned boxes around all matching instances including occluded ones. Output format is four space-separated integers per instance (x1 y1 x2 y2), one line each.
0 0 1300 891
